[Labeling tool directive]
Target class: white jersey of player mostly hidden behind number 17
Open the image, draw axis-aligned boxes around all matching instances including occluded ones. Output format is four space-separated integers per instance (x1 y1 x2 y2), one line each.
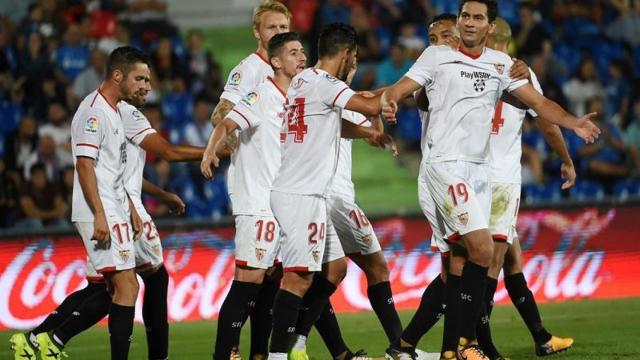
118 101 156 217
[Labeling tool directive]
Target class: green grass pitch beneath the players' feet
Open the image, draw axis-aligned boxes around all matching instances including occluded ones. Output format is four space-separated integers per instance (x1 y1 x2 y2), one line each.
0 298 640 360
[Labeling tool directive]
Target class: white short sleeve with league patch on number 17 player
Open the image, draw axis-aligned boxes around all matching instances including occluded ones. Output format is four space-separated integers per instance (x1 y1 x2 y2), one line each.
71 107 107 159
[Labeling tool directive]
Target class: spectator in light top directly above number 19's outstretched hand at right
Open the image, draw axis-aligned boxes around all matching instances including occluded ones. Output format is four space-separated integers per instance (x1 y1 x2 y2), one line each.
562 55 604 116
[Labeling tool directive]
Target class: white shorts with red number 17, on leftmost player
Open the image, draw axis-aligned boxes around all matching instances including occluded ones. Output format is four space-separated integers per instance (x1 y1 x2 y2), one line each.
73 221 136 274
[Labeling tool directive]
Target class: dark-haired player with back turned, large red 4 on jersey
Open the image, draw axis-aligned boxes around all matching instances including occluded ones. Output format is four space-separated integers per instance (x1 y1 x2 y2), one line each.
269 24 391 359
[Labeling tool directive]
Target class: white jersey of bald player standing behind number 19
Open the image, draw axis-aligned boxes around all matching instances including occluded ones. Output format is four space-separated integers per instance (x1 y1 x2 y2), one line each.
489 69 542 184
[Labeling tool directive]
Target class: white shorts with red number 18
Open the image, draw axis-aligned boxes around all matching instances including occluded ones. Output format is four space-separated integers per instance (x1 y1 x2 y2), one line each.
235 215 280 269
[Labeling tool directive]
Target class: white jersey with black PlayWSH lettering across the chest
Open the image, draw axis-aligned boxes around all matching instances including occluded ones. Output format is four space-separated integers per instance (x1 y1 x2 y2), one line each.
405 46 527 163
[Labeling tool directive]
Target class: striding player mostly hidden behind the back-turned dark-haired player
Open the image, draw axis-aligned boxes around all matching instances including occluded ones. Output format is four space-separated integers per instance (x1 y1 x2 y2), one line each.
289 59 402 360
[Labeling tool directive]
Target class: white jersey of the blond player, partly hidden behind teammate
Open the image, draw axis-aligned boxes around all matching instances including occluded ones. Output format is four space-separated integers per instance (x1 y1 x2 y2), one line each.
220 52 273 194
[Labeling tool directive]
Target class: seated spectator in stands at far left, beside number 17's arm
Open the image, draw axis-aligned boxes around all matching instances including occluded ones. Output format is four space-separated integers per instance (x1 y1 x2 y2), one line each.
16 163 68 229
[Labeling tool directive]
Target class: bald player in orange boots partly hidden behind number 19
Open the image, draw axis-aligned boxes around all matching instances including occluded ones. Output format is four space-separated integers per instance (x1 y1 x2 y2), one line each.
478 18 576 358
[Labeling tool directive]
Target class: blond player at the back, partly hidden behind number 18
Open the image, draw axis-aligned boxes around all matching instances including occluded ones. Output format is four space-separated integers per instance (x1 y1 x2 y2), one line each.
203 0 291 359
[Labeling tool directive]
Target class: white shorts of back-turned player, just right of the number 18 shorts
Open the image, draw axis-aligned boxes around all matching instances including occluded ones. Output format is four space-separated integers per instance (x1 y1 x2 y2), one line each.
271 191 327 271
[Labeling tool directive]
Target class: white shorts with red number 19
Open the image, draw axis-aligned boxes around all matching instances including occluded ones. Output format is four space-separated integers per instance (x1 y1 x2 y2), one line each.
425 161 491 243
